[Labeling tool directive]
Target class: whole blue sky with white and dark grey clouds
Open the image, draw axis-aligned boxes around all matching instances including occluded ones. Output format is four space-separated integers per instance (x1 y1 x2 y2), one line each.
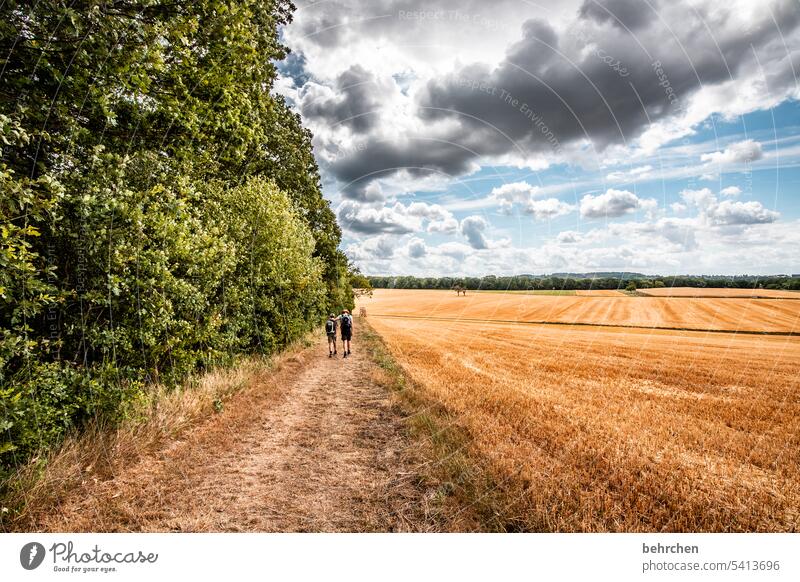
277 0 800 275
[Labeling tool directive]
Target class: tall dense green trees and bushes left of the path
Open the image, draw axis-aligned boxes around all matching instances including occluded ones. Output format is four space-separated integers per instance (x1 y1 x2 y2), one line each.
0 0 354 477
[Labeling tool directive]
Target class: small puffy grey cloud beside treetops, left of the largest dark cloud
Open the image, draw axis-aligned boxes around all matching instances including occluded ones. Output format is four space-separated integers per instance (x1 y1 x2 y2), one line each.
300 65 383 133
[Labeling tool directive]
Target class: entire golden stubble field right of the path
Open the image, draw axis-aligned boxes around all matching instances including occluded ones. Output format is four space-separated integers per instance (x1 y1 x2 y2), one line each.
359 290 800 531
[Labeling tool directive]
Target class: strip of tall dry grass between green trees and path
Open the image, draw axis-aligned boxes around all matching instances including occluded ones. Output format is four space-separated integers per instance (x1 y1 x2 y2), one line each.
0 338 309 531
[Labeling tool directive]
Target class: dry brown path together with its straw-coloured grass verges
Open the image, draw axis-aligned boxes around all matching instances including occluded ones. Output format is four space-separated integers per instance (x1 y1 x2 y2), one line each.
0 330 450 532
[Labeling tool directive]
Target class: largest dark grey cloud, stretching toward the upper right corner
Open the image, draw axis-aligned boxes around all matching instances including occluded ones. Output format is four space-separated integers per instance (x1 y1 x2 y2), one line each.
422 2 800 151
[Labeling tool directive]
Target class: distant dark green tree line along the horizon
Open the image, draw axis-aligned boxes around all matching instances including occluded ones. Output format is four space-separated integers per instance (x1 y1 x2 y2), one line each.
367 273 800 291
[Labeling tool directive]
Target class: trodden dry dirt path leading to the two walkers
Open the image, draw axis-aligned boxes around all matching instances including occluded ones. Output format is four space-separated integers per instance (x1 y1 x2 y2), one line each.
36 330 426 531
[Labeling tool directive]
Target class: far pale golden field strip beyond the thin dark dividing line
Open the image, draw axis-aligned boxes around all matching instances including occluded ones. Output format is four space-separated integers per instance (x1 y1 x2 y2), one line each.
360 289 800 333
